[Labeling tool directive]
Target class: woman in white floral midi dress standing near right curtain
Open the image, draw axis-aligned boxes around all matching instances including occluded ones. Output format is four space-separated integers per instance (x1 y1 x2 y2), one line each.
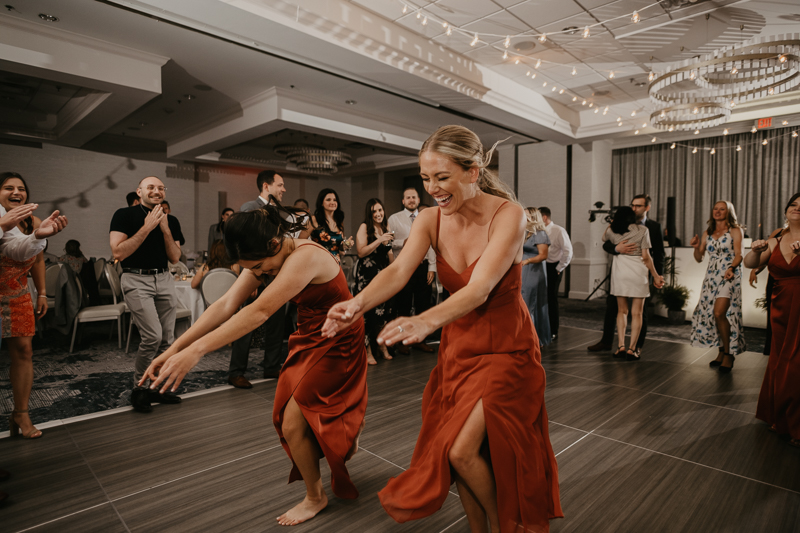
690 200 745 373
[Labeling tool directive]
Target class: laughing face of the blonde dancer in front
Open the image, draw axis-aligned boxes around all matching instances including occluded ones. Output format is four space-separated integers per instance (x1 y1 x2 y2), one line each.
419 152 478 215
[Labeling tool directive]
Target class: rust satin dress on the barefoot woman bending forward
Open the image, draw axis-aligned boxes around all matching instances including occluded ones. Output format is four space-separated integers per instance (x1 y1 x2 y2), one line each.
272 244 367 499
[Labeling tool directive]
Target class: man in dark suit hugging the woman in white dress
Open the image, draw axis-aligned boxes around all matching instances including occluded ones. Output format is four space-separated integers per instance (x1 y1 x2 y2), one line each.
587 194 665 352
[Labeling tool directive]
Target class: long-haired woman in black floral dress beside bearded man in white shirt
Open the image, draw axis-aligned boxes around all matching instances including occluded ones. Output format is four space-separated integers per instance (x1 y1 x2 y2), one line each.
354 198 394 365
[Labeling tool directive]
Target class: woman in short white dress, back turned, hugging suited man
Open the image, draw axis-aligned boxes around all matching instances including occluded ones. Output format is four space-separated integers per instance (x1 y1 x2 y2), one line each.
603 206 664 361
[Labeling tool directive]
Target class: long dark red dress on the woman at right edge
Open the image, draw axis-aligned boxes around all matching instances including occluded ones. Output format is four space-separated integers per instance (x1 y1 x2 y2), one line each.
756 239 800 440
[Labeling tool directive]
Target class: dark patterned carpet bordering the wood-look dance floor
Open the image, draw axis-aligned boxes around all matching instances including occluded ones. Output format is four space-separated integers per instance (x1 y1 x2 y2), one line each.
0 299 764 431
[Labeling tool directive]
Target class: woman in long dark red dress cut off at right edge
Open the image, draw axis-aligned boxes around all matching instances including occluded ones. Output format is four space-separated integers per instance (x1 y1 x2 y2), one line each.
744 193 800 447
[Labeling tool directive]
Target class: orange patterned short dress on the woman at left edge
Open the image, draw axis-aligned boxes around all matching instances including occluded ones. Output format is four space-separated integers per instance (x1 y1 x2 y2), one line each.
0 256 36 339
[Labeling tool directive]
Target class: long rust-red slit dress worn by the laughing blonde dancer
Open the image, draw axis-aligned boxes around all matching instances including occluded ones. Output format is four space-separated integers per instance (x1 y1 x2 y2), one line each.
378 208 563 533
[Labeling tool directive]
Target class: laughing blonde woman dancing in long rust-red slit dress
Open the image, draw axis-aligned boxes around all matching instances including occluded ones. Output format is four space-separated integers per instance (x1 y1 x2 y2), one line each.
323 126 563 533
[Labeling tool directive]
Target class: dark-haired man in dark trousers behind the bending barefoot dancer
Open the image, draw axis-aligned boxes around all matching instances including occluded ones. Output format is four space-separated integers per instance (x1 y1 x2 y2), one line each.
228 170 286 389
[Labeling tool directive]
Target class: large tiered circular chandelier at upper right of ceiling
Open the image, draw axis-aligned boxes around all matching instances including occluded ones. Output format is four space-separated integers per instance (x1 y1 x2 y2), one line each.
648 33 800 131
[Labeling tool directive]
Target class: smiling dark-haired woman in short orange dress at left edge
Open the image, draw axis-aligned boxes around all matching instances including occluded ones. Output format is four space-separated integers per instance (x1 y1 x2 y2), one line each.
0 172 47 439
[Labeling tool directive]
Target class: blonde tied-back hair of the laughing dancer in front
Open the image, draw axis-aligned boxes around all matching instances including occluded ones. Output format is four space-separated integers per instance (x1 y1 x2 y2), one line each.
419 126 532 231
